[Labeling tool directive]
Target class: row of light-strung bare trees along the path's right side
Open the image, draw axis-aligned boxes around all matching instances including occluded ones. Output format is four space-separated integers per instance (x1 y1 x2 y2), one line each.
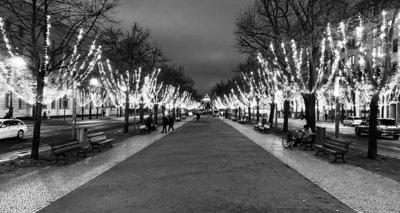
215 0 400 158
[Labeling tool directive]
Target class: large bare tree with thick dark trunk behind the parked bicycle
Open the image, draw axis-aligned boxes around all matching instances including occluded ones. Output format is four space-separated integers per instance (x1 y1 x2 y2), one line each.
235 0 347 130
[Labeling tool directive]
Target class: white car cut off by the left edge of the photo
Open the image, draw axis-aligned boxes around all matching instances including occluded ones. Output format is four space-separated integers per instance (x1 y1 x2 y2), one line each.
0 119 28 139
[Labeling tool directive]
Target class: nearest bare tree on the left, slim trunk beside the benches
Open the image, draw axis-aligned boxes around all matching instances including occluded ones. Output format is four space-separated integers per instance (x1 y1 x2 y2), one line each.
0 0 118 159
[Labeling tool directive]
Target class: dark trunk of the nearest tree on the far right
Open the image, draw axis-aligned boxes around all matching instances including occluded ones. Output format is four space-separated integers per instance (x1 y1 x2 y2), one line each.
368 93 379 159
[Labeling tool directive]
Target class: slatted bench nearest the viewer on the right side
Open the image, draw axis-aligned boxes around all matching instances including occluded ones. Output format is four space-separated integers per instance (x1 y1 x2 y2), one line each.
314 139 351 163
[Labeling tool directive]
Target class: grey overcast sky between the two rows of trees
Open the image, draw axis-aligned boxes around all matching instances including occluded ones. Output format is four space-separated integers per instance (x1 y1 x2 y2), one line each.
118 0 252 93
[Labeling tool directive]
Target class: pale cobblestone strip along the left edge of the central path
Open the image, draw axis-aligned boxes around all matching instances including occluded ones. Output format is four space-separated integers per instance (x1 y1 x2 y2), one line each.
0 118 191 213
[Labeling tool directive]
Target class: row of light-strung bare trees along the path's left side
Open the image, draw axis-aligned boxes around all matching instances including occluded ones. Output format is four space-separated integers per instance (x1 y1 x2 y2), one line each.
0 0 200 159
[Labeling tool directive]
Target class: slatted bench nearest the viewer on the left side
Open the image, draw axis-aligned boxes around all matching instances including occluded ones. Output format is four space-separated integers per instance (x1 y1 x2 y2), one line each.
49 141 89 163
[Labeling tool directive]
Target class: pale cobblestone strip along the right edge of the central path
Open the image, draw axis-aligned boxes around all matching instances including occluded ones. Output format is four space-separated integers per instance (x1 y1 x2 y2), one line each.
224 119 400 213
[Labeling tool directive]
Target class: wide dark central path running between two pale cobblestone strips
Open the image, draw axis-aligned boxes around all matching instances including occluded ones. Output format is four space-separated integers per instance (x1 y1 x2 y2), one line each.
42 118 352 212
